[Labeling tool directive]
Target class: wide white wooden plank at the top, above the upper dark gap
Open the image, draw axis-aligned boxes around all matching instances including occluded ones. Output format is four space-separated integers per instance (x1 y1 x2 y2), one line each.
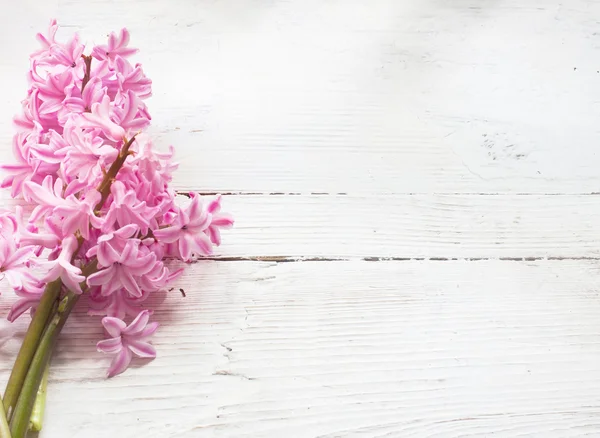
0 0 600 194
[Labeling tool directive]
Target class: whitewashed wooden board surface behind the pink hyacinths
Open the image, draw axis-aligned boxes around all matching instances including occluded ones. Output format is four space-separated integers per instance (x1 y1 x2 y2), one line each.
0 0 600 438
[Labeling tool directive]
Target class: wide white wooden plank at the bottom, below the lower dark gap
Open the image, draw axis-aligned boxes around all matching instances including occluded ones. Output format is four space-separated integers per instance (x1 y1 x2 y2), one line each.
0 261 600 438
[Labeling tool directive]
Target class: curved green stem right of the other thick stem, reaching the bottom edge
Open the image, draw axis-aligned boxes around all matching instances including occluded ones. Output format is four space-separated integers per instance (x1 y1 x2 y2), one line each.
10 292 79 438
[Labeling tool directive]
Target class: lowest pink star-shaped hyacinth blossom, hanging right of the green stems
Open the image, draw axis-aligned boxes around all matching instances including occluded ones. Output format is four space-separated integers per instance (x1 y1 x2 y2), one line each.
96 310 158 377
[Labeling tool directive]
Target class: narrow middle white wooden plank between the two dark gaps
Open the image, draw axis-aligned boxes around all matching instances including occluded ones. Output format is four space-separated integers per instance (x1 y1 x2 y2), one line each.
217 195 600 258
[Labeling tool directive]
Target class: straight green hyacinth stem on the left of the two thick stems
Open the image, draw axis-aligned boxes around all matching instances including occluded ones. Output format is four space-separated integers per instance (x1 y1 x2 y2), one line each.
2 280 62 418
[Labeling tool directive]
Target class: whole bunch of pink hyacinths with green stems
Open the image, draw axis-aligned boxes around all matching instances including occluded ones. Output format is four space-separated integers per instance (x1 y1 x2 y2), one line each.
0 20 233 438
